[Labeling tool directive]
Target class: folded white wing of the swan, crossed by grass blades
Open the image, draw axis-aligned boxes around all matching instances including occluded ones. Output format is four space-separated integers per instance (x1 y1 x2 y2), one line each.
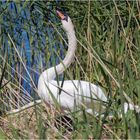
53 80 107 106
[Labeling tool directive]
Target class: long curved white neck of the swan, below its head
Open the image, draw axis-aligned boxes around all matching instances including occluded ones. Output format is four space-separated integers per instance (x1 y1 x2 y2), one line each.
40 28 77 82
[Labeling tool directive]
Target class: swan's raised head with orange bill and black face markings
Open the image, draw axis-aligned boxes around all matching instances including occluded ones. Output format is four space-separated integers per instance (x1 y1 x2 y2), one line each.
57 9 74 32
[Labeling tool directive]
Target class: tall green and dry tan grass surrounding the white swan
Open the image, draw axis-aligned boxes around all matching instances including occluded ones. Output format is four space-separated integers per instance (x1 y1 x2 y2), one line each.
0 0 140 139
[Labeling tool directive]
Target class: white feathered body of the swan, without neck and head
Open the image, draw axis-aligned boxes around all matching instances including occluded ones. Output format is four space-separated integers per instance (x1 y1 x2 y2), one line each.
37 80 107 108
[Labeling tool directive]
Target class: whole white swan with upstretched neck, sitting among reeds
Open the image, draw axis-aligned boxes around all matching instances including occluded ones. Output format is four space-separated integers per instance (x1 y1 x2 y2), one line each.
38 11 107 113
